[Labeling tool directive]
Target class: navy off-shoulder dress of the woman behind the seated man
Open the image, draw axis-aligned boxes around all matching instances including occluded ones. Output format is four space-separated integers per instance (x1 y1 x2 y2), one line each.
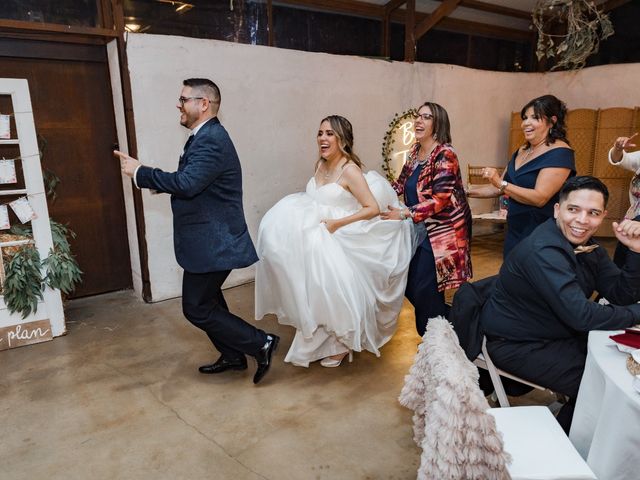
503 147 576 258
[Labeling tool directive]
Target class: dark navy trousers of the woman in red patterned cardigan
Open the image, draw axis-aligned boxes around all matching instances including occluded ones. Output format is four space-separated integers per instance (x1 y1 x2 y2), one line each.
404 238 448 336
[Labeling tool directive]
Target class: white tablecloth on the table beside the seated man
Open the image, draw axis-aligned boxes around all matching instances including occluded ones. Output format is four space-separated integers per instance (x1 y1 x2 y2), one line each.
569 331 640 480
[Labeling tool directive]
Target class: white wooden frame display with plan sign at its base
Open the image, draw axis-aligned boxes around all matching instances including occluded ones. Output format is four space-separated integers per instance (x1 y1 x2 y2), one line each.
0 78 65 350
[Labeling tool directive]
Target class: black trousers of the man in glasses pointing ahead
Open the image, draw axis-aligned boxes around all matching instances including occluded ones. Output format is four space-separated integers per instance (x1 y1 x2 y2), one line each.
182 270 267 362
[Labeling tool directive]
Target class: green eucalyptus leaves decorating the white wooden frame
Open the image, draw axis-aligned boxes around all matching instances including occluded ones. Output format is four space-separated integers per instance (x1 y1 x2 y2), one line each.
2 220 82 318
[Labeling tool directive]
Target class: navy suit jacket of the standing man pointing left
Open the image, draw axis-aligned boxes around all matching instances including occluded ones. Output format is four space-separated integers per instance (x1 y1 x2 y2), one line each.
136 118 258 273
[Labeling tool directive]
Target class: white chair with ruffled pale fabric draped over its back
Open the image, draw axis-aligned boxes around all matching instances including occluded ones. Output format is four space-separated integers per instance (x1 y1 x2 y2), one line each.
400 317 596 480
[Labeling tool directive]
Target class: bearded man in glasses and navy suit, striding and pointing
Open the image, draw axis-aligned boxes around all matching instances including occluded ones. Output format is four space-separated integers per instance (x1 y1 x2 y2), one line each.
114 78 280 383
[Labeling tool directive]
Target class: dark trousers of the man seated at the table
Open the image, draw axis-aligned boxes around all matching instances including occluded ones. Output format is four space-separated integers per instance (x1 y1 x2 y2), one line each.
487 335 587 434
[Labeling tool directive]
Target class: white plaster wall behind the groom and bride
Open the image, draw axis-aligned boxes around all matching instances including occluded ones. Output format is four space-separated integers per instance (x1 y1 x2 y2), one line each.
121 34 640 300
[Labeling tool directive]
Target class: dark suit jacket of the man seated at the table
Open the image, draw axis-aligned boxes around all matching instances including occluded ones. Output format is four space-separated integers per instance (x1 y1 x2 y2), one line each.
480 219 640 341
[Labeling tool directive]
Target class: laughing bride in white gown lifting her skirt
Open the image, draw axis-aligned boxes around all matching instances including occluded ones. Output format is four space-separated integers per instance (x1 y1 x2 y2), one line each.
256 115 412 367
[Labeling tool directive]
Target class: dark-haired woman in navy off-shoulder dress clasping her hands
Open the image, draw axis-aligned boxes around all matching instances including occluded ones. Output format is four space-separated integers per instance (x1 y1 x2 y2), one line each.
467 95 576 258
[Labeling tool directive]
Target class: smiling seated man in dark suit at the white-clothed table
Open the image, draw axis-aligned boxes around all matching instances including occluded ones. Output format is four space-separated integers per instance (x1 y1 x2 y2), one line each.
480 176 640 432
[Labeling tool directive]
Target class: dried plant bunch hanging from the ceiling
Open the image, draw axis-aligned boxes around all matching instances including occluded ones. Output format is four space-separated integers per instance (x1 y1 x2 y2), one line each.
533 0 613 70
